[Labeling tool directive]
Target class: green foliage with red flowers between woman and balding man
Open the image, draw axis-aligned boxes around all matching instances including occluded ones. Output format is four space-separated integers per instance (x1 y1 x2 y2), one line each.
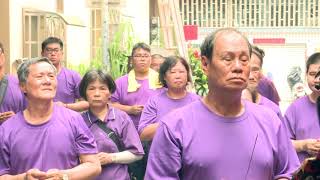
188 48 208 96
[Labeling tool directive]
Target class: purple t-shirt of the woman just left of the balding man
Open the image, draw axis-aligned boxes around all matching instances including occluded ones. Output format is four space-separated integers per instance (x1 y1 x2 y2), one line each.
138 91 200 134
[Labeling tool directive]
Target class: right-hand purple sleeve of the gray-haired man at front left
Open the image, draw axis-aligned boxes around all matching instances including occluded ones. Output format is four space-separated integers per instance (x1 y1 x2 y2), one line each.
71 114 98 154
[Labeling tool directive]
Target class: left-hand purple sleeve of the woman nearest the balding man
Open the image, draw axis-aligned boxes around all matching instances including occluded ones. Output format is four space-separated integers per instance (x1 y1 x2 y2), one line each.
138 96 158 134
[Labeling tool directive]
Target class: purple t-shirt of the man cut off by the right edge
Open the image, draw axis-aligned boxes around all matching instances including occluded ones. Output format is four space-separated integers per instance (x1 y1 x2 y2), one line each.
284 96 320 162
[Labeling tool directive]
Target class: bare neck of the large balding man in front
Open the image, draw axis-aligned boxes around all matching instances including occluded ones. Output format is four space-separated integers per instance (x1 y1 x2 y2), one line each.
203 91 245 117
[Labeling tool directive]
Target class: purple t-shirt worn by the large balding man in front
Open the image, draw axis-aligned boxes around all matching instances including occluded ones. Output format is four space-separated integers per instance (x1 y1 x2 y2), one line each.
145 101 299 180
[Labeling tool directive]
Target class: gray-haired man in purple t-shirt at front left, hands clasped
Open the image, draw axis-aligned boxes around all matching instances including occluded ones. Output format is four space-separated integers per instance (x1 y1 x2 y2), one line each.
0 58 101 180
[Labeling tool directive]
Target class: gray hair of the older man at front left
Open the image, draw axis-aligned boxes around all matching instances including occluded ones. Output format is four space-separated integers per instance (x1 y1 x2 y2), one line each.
17 57 57 84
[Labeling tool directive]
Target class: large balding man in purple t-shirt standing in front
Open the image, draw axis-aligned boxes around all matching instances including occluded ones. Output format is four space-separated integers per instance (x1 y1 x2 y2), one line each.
145 28 299 180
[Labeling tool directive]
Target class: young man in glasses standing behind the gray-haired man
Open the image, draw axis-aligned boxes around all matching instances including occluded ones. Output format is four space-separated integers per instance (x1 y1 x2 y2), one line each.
41 37 89 111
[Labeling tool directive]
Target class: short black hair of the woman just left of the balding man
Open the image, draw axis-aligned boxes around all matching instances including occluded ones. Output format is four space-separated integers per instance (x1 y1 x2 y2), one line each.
159 56 191 87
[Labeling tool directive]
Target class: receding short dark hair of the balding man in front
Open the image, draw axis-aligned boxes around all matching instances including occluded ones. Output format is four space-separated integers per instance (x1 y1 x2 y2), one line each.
200 28 252 61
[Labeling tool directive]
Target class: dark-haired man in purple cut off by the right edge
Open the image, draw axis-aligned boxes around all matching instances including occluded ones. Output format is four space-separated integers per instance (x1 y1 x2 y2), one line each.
284 53 320 162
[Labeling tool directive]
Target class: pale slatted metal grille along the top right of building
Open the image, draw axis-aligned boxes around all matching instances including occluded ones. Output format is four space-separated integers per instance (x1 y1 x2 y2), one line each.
179 0 320 28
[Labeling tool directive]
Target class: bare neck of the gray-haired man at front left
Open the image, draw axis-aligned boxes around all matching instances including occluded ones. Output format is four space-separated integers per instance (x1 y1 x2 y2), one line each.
23 101 54 125
